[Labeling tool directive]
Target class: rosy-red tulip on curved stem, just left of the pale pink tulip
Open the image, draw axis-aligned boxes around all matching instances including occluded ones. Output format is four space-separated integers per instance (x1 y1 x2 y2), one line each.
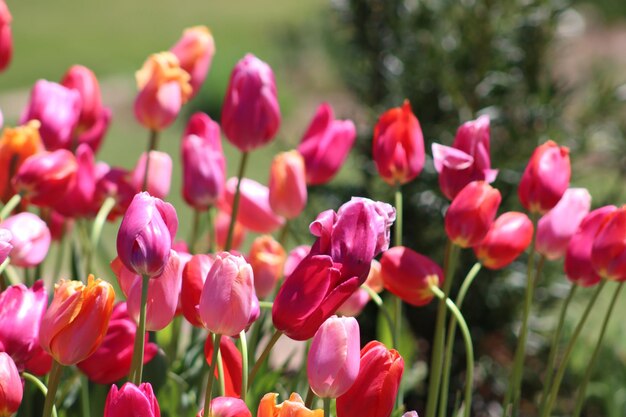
473 211 534 269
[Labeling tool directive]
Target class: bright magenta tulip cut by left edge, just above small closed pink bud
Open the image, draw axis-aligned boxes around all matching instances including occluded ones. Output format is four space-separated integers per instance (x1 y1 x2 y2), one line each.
0 281 48 370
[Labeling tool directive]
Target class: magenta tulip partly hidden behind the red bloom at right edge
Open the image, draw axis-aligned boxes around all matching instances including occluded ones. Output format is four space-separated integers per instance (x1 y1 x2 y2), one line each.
564 206 617 287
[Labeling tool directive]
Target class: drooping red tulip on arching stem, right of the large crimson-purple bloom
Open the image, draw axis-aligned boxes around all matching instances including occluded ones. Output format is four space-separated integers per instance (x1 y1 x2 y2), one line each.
380 246 443 307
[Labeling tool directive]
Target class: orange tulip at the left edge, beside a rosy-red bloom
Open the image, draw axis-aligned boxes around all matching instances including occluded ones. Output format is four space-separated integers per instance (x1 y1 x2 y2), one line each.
0 119 44 203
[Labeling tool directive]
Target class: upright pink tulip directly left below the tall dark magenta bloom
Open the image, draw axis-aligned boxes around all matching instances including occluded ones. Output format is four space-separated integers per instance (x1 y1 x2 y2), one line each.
181 113 226 210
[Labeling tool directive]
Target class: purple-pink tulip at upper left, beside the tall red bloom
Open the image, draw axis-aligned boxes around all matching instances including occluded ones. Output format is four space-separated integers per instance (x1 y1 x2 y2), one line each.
20 80 81 151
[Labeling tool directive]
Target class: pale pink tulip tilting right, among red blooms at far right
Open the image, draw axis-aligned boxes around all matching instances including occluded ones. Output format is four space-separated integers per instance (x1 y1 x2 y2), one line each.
535 188 591 261
